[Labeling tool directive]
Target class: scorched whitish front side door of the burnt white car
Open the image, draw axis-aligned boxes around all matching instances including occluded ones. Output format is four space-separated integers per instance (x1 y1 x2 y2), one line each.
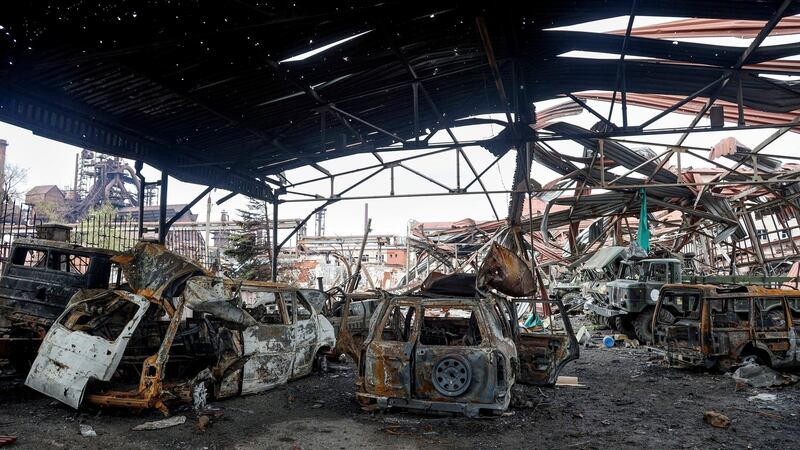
241 288 294 394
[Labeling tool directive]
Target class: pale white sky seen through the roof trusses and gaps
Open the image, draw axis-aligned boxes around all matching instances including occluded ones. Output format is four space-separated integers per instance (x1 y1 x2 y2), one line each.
0 17 800 241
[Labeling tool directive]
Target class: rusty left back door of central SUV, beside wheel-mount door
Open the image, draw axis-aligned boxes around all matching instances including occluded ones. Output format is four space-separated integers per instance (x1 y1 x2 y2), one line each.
364 301 419 399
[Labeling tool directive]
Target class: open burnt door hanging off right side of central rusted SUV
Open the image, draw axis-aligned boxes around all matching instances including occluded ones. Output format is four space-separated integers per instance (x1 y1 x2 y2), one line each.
516 301 580 386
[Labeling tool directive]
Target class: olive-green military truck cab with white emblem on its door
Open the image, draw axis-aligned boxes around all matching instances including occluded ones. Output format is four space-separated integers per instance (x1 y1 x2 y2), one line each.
586 258 683 343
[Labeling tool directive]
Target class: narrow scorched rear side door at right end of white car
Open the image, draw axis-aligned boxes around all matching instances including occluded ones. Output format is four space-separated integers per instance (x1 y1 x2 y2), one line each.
283 292 317 378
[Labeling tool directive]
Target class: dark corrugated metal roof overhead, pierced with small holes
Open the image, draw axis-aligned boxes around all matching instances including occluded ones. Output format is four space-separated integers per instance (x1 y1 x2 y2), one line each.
0 0 800 198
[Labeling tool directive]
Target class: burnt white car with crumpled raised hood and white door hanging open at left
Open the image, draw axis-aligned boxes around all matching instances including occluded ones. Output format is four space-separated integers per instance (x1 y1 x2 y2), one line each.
25 244 335 413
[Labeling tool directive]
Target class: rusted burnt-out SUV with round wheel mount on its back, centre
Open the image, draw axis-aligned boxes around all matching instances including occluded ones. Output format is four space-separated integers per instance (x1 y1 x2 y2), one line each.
356 296 578 417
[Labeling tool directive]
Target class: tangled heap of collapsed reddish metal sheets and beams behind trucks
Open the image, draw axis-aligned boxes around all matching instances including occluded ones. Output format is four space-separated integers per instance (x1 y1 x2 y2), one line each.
409 123 800 280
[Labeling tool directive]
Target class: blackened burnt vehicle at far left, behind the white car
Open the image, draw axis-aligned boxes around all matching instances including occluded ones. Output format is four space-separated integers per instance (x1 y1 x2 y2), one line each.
0 238 120 370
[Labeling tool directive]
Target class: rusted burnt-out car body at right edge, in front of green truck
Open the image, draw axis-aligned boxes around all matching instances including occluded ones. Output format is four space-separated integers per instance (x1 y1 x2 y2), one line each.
653 284 800 371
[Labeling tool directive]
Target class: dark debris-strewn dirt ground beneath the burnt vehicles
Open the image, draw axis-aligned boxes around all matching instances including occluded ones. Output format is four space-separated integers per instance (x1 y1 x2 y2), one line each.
0 314 800 450
